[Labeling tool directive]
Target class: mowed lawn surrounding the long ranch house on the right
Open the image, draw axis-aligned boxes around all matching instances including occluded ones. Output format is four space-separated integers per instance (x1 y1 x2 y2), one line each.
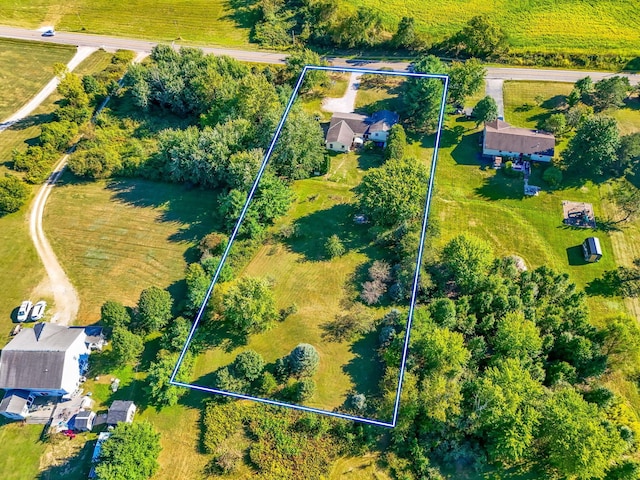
433 82 640 325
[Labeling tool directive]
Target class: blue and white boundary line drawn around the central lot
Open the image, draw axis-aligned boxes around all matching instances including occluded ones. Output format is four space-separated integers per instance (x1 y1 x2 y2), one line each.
169 65 449 428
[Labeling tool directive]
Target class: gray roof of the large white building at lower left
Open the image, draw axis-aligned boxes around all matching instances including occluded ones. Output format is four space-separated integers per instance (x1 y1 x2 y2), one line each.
0 323 85 390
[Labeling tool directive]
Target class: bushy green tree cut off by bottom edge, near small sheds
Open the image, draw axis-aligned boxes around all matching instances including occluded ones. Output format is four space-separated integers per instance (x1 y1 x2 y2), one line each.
95 421 162 480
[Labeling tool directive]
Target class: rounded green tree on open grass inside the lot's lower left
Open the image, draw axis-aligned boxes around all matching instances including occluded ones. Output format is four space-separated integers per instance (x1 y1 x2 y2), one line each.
222 277 277 334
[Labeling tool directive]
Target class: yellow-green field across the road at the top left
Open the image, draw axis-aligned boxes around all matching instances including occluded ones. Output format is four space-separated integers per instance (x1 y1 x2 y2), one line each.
0 0 253 48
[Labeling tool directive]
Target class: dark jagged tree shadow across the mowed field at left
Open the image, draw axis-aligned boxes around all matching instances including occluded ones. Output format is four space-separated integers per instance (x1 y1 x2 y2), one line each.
107 179 222 248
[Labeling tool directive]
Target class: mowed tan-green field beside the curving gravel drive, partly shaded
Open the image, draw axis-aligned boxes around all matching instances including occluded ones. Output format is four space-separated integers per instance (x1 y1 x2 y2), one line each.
44 173 218 324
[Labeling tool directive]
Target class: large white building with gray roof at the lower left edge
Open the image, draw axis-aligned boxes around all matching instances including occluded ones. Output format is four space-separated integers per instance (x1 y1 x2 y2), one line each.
0 323 89 418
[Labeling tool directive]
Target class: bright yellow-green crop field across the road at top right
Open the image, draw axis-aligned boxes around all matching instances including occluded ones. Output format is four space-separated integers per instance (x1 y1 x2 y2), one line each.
349 0 640 55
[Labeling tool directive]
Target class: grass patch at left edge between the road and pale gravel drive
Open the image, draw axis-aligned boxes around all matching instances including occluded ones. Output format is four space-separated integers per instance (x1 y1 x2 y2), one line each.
0 38 76 122
